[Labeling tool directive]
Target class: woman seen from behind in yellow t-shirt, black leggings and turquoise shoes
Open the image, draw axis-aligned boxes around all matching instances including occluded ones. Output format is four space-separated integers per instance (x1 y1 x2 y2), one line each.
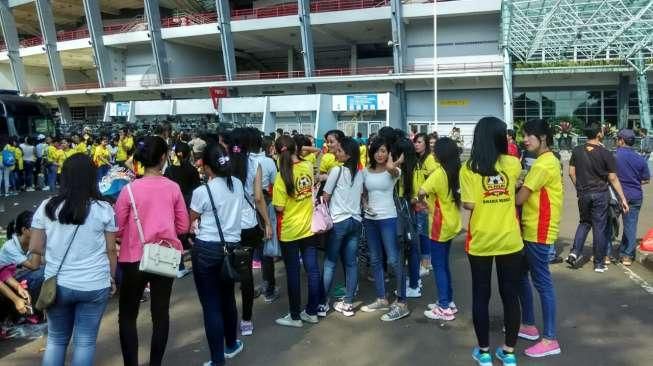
460 117 524 364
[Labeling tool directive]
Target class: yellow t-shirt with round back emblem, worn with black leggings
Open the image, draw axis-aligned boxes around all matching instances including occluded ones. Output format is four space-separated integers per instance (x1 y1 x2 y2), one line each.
460 155 524 256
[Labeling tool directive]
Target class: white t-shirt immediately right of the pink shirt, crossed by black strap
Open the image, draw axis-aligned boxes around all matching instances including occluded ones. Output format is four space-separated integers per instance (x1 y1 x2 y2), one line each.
190 177 247 243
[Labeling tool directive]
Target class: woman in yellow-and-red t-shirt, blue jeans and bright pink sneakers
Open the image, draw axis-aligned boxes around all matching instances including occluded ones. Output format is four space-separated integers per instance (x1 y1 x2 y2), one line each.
517 119 563 357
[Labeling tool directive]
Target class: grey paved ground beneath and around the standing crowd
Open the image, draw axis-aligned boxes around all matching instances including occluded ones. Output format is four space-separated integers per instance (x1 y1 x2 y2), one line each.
0 164 653 366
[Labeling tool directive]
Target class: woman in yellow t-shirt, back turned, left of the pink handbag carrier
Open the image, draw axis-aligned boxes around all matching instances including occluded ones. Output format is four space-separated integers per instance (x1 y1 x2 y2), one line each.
272 136 322 327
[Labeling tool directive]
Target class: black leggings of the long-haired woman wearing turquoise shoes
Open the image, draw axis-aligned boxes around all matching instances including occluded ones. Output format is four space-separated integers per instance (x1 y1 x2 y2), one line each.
467 251 525 348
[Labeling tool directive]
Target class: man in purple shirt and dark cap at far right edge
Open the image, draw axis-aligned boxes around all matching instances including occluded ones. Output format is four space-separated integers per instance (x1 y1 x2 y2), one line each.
615 129 651 266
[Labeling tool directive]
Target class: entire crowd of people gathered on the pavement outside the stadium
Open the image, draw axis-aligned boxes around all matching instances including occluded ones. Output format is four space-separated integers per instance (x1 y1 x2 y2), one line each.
0 117 649 366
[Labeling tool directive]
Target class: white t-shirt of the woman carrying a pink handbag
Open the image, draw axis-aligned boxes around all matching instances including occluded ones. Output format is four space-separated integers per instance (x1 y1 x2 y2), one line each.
324 167 363 223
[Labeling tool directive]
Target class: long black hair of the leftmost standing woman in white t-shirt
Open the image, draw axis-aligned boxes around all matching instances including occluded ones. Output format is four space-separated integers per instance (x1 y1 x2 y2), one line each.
45 154 102 225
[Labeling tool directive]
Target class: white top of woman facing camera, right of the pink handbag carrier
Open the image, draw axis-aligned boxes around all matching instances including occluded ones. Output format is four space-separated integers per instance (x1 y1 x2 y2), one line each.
363 169 401 220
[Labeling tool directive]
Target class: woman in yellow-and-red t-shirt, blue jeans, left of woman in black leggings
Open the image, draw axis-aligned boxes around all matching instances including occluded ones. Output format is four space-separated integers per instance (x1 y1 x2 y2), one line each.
418 135 461 321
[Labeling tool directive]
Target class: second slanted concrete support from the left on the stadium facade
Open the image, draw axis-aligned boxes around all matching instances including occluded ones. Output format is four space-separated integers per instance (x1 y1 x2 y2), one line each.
36 0 65 90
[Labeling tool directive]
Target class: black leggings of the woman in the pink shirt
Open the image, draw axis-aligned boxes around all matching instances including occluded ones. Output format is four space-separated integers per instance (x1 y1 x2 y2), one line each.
118 262 173 366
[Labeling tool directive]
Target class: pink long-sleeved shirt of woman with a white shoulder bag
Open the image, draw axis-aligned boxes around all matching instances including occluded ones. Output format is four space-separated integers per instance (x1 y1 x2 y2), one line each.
114 177 189 263
